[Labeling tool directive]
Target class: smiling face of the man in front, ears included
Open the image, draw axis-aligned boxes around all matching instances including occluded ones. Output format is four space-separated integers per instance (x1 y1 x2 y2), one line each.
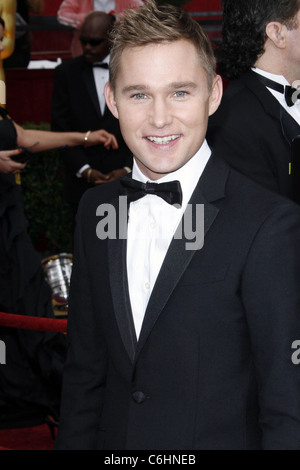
105 40 222 180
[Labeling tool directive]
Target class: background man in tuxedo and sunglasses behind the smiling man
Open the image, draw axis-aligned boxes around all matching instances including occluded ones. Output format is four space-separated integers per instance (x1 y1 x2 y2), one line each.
52 12 132 222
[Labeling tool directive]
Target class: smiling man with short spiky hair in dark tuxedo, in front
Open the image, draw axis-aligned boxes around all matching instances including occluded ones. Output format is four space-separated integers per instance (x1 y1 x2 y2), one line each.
56 0 300 455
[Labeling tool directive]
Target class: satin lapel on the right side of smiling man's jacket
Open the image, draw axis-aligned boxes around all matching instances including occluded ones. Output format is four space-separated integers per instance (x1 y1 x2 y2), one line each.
135 159 229 360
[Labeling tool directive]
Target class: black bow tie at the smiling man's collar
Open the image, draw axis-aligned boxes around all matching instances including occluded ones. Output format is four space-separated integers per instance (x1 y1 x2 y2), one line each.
120 176 182 206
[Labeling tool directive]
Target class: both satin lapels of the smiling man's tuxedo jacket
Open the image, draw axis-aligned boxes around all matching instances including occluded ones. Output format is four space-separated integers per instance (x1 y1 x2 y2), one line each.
108 156 229 363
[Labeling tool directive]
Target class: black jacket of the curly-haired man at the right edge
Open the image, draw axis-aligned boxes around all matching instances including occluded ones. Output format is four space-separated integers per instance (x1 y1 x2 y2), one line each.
207 71 300 198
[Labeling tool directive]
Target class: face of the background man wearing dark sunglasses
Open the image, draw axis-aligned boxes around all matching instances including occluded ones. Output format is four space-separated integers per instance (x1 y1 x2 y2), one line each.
80 21 109 63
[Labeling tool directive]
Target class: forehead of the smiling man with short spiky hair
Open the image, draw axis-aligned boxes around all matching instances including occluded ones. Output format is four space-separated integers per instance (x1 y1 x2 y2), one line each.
117 40 206 84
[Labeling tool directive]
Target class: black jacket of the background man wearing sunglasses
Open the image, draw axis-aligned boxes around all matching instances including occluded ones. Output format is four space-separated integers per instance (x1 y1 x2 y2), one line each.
51 56 132 204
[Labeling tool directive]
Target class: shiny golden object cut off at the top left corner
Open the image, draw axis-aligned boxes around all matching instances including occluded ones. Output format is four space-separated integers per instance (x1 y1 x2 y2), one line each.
0 0 17 60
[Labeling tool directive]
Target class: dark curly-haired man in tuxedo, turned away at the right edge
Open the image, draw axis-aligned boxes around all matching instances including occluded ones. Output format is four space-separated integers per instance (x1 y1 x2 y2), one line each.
207 0 300 198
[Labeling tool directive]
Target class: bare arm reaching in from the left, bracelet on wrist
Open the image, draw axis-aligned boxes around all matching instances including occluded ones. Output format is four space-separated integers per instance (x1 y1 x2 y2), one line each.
14 122 118 152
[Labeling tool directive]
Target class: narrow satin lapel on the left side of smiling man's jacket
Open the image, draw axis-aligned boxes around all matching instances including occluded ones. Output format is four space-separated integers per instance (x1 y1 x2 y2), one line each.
108 195 137 362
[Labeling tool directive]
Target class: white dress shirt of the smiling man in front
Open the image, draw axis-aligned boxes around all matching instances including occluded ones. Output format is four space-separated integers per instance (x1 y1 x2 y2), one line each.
127 141 211 338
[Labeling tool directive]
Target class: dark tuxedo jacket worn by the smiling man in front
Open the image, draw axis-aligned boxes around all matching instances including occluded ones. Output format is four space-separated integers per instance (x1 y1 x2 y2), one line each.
56 157 300 450
